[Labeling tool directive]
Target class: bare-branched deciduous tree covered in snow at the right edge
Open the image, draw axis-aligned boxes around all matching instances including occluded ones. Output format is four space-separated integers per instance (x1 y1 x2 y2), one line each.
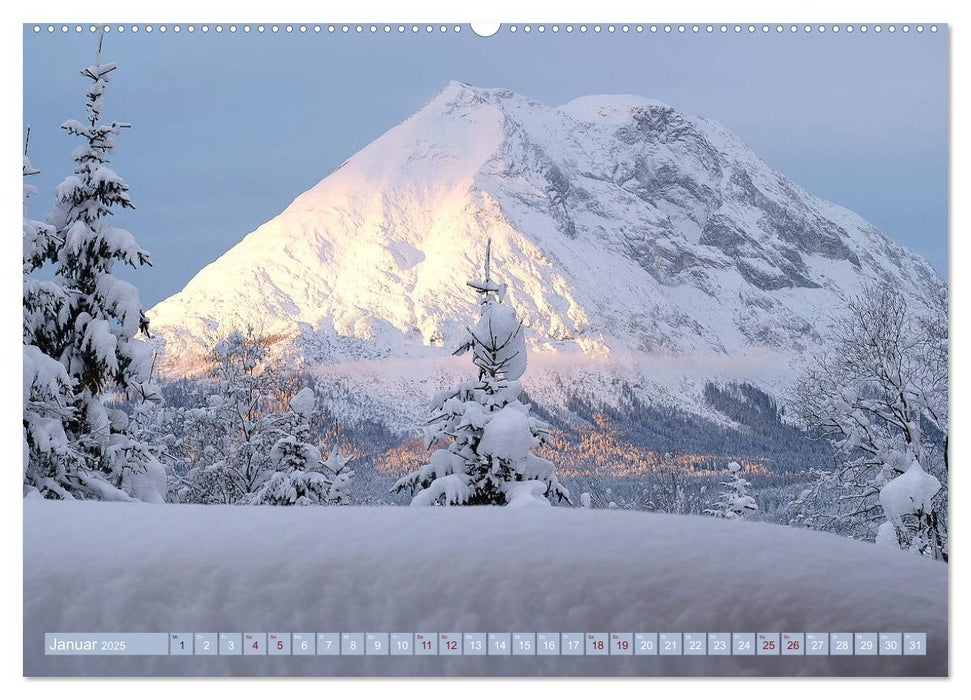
792 287 948 560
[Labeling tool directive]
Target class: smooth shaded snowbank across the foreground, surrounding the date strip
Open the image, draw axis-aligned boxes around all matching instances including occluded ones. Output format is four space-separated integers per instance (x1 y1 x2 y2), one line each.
24 500 948 676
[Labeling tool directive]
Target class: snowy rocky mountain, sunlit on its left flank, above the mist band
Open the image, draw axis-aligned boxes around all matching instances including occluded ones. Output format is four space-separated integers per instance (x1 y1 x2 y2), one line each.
149 82 942 426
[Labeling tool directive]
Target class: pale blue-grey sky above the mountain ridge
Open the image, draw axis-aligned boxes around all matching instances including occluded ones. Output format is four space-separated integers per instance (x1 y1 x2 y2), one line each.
24 27 948 305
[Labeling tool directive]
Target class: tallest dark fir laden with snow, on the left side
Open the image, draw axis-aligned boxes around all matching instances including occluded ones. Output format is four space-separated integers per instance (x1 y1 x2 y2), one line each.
24 42 164 501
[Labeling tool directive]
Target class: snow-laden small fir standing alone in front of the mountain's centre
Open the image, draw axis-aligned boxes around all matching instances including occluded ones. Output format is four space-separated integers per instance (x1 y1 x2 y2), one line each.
392 241 569 506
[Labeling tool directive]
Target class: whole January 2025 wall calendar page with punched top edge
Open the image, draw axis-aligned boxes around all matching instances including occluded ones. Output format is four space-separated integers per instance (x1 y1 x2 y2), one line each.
21 22 949 677
